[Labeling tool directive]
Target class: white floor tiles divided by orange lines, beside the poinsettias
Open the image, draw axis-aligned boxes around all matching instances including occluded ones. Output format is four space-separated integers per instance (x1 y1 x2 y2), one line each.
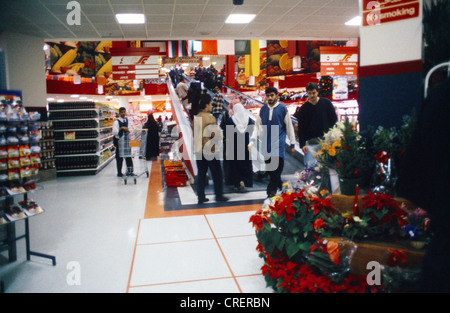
129 211 271 293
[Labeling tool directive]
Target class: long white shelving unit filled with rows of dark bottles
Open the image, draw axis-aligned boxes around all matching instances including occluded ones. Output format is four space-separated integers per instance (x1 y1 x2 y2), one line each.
49 102 115 176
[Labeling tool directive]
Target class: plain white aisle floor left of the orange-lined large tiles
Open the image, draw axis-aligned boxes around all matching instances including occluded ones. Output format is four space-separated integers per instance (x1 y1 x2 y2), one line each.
0 161 151 293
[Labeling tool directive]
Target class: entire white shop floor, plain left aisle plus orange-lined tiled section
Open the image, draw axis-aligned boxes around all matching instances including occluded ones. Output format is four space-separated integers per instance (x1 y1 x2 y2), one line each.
0 161 272 293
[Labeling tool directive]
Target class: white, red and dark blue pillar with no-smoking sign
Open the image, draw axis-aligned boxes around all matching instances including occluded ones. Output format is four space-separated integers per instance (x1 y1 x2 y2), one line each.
359 0 423 130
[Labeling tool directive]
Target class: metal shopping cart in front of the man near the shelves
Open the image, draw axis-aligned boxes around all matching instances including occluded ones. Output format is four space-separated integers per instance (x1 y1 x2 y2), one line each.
118 129 150 185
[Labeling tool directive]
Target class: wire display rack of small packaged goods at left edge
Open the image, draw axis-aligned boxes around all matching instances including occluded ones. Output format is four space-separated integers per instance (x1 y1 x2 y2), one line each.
0 100 56 291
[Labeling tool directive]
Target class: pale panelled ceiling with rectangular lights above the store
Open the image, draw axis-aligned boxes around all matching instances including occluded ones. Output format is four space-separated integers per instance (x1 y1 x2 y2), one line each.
0 0 359 40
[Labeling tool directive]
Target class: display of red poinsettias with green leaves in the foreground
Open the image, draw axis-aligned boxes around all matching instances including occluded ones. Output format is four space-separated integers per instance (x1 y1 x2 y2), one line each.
249 189 424 293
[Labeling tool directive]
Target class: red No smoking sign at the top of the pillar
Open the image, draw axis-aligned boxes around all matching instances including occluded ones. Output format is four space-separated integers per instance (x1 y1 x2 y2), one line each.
362 0 420 26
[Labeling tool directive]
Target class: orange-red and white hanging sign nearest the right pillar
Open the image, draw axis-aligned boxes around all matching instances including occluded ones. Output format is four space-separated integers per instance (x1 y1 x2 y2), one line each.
320 46 358 76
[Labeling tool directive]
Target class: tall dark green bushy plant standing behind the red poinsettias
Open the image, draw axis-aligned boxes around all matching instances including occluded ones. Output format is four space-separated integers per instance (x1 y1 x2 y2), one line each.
336 119 368 195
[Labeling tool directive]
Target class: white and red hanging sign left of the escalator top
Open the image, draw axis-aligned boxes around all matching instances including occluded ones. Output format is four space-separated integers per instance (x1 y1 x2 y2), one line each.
112 55 159 80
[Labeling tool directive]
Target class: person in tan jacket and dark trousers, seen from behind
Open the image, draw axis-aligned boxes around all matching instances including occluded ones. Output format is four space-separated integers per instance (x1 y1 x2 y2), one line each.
193 94 228 204
